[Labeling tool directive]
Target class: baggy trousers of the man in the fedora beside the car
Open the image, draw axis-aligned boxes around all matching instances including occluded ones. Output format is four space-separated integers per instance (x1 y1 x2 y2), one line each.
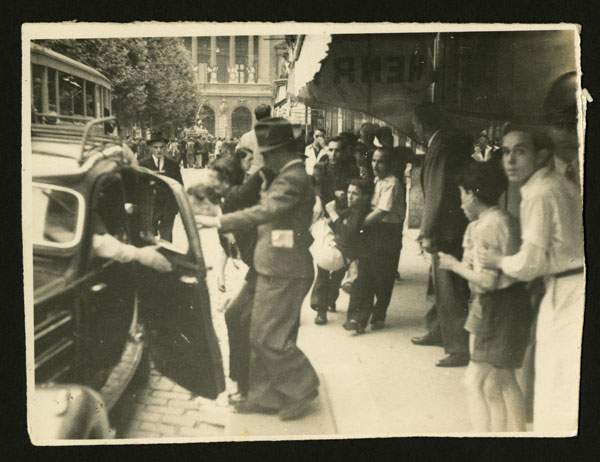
248 274 319 409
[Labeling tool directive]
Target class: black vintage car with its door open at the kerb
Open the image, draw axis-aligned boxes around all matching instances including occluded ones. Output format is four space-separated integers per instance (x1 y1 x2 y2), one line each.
29 119 225 439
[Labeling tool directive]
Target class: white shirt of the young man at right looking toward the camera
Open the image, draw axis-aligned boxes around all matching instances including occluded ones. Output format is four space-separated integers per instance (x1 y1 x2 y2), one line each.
500 167 584 281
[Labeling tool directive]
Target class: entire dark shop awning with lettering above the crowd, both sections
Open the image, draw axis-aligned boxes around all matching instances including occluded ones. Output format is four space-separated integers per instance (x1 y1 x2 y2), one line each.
288 30 576 136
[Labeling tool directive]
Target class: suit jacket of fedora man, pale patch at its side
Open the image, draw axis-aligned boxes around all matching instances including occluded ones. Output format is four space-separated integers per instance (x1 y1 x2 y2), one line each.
221 161 315 279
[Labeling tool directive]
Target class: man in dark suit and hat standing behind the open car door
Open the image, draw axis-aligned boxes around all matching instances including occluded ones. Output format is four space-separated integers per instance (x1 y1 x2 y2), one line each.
140 132 183 242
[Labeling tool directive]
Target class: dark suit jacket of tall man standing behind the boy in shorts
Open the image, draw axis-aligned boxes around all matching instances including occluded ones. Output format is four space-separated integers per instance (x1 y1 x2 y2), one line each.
420 130 471 245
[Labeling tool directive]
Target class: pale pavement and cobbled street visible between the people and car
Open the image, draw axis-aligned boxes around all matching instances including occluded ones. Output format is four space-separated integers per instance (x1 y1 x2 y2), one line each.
116 169 470 439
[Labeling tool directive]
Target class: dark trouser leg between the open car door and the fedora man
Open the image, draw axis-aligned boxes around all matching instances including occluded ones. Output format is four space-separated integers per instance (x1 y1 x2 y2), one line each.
225 268 256 394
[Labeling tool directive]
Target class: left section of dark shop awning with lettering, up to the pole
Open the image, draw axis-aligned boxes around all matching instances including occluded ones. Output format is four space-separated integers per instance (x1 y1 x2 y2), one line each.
288 34 435 133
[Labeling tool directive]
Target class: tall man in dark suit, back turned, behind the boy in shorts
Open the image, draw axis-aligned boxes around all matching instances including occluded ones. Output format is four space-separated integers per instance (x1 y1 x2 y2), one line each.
413 103 471 367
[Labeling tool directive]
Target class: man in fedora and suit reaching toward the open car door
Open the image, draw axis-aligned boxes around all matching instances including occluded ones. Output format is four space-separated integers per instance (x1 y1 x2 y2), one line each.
196 118 319 420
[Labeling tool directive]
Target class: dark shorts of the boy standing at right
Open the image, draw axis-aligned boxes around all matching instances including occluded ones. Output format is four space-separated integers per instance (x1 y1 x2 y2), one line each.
471 283 533 369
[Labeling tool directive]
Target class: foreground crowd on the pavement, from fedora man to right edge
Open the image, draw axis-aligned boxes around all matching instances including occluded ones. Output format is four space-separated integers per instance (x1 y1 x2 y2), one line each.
141 73 584 432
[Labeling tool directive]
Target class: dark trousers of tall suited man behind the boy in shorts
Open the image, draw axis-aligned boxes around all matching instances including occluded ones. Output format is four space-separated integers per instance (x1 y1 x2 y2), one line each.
432 240 469 354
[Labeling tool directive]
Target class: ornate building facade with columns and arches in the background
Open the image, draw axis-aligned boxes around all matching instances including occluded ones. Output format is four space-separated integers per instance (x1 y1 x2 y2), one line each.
184 35 285 138
